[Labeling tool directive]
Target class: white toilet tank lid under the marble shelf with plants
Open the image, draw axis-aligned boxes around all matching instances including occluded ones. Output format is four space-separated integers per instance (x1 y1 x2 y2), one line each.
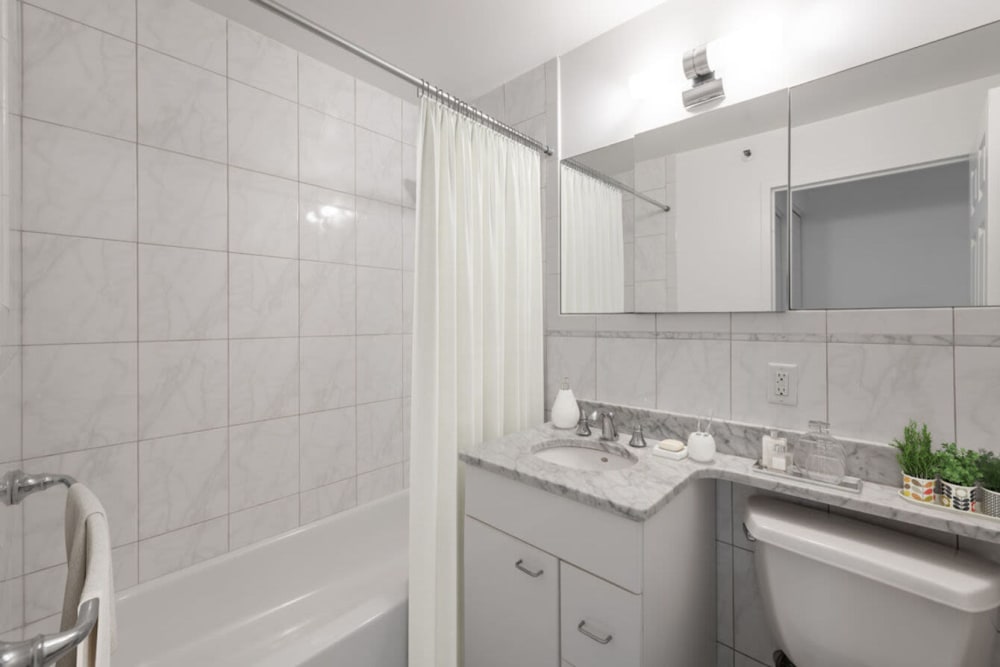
746 496 1000 613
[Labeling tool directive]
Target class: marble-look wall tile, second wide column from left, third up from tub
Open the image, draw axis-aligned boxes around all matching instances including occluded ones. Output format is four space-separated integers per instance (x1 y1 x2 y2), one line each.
139 340 228 438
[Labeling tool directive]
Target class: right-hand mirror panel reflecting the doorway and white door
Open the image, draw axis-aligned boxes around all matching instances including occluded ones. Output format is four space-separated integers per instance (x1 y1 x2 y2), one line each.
789 23 1000 309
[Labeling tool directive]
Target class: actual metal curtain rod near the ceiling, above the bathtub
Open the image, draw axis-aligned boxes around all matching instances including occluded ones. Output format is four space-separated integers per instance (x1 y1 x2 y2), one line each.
244 0 552 155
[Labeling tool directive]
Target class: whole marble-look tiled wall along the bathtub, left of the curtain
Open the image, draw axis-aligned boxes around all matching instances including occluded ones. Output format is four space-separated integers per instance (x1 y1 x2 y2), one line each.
0 0 416 637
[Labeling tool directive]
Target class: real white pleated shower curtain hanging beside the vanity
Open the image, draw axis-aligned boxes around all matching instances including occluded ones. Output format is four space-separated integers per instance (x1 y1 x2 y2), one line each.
409 97 544 667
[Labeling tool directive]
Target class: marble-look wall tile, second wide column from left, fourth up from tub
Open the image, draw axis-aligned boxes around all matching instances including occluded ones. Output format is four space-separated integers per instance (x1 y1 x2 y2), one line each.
139 245 229 341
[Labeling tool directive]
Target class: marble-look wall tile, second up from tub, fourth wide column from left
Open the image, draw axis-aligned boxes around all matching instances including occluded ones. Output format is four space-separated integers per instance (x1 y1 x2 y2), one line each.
299 406 356 491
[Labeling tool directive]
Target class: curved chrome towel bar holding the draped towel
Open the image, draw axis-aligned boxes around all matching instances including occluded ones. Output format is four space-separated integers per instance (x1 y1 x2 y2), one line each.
0 470 101 667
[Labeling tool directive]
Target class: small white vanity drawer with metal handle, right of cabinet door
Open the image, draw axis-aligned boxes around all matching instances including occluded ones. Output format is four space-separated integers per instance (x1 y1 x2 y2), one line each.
559 563 642 667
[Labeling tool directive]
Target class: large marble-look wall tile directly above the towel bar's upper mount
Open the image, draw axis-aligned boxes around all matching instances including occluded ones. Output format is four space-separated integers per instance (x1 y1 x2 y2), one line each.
23 343 138 458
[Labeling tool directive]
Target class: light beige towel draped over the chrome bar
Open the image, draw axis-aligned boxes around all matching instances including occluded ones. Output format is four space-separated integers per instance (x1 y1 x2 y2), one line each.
59 484 117 667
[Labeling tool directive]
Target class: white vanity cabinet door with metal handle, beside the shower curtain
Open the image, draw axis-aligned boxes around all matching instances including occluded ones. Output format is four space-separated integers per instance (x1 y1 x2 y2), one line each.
464 517 559 667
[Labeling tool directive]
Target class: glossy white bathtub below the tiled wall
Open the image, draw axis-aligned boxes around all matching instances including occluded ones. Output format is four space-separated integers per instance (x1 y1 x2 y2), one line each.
113 491 408 667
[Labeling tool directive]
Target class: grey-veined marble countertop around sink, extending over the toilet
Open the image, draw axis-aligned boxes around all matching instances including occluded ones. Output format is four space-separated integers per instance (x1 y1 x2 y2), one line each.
459 424 1000 543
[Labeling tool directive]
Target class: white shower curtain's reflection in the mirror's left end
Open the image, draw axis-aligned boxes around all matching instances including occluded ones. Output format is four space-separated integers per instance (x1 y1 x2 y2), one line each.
560 165 625 313
